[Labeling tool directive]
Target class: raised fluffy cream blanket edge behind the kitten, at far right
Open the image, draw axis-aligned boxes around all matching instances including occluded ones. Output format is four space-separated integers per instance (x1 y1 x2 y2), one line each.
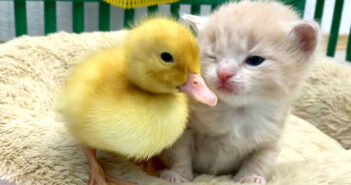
293 59 351 149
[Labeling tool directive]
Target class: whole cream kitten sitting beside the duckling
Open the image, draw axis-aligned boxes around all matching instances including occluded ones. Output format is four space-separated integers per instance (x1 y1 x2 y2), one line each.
160 1 319 184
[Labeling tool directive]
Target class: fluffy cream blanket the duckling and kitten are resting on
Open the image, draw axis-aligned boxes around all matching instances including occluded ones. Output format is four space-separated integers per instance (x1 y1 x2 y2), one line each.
0 31 351 185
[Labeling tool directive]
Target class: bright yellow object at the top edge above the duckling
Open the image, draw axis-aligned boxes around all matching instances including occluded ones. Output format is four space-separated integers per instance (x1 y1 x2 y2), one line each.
104 0 179 9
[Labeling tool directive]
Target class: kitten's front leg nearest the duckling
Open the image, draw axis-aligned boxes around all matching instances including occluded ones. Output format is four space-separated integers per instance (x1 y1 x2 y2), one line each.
160 129 194 184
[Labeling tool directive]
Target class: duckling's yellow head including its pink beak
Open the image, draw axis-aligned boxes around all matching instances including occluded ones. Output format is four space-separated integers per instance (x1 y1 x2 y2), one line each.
125 17 217 106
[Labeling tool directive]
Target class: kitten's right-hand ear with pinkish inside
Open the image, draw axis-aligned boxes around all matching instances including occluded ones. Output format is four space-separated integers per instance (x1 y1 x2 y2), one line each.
290 21 319 55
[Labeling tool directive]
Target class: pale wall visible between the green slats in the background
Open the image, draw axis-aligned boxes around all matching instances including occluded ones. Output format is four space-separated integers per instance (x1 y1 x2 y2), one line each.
0 0 351 41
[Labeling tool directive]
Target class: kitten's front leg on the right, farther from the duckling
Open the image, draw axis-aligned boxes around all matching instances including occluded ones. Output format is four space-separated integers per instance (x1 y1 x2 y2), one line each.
234 143 279 184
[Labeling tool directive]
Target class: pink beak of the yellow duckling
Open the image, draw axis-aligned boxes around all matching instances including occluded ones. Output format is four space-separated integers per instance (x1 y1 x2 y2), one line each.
179 73 217 107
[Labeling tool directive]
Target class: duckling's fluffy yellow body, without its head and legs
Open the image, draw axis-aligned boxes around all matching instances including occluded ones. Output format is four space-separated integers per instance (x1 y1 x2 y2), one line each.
61 48 188 159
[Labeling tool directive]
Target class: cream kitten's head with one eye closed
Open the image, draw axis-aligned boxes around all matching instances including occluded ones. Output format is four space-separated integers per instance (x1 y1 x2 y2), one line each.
182 1 319 105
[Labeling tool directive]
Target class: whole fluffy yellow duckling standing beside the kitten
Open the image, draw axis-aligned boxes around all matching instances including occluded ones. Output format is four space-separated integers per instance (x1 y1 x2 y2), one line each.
57 17 217 185
